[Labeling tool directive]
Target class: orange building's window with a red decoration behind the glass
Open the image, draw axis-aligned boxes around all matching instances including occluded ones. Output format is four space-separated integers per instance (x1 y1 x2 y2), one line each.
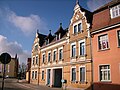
98 34 109 50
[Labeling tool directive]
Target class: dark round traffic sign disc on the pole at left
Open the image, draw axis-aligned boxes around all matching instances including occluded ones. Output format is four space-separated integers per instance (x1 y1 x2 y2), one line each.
0 53 11 64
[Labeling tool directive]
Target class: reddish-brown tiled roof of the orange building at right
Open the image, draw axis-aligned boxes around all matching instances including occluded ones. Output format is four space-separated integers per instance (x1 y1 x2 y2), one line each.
91 0 120 32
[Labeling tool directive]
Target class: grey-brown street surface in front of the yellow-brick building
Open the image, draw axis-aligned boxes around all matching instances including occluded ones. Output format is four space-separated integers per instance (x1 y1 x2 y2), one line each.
0 78 62 90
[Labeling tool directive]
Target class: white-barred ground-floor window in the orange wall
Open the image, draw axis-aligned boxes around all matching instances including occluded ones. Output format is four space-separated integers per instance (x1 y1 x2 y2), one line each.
99 65 110 81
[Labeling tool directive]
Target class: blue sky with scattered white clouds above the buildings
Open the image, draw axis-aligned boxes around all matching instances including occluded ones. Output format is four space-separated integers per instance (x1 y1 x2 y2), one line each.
0 0 111 64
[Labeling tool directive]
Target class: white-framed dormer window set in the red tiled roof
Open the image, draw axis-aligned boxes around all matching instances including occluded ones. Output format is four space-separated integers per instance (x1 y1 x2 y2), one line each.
110 4 120 18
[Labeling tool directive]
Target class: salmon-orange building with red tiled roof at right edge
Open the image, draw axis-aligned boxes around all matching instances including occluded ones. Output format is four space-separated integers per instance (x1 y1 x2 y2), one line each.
91 0 120 90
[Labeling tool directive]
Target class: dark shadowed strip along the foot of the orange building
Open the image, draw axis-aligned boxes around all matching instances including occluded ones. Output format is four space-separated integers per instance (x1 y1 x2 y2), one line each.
85 83 120 90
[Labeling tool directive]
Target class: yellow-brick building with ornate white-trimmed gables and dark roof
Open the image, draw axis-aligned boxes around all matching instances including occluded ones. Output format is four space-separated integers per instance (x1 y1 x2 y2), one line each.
31 2 92 90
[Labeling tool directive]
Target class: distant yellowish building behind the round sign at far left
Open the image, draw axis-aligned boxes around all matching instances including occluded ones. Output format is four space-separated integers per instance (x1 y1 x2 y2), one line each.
0 56 19 78
